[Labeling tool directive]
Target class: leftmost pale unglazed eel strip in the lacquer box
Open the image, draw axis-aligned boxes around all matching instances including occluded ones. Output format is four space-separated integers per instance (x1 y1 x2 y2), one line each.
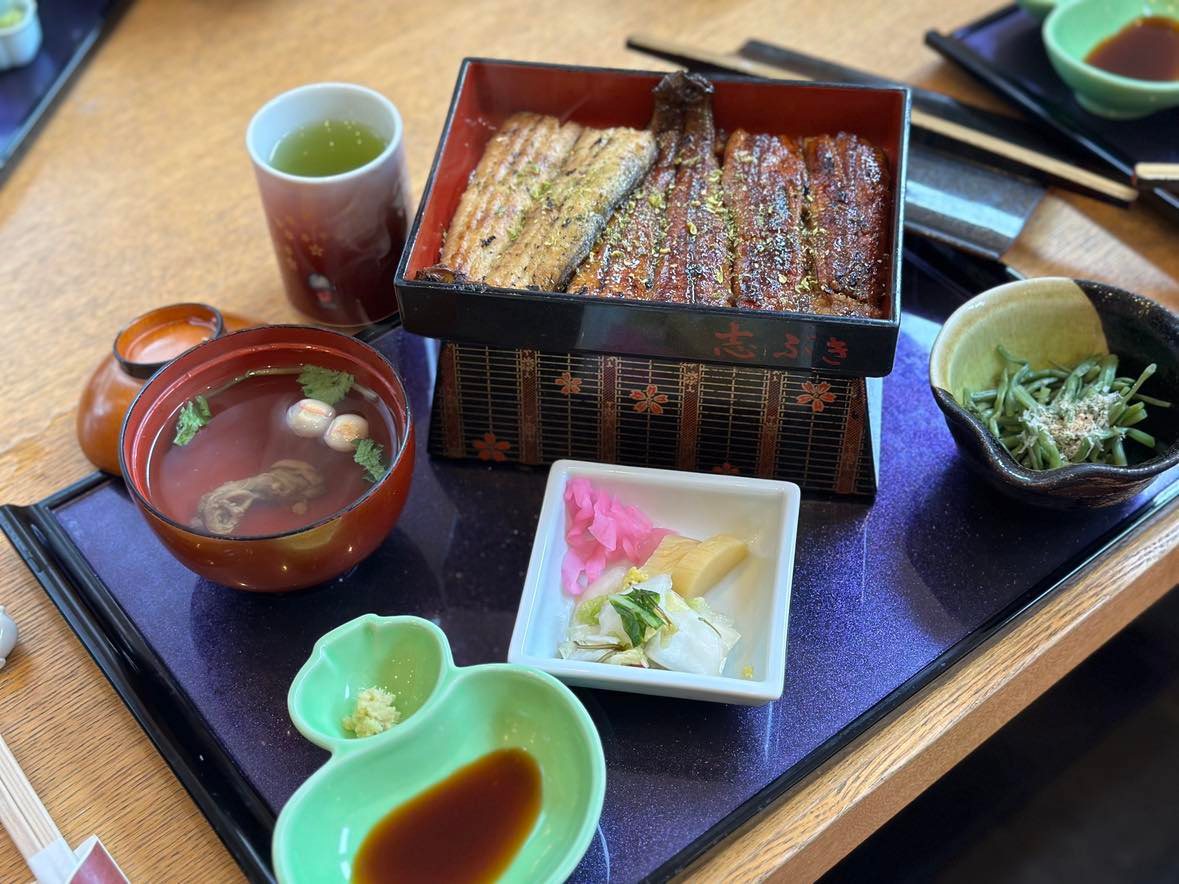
419 112 581 282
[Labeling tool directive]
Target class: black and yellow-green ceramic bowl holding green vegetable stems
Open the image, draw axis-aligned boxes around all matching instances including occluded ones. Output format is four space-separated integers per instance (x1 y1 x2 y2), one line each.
929 277 1179 508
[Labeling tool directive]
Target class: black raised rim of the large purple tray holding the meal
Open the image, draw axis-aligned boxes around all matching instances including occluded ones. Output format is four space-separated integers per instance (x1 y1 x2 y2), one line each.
9 473 1179 882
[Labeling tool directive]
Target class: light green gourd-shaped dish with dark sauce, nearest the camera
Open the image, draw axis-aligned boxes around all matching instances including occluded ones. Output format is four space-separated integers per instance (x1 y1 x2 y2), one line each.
274 614 606 884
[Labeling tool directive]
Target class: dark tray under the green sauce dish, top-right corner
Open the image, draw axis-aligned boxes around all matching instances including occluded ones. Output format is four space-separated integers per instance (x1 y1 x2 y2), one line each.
926 6 1179 220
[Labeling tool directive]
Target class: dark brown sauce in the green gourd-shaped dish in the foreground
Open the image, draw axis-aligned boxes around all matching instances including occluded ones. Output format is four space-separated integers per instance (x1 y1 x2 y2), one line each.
351 748 540 884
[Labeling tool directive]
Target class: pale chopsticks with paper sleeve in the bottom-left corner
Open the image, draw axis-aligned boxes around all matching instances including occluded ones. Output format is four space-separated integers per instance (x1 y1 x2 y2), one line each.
0 735 130 884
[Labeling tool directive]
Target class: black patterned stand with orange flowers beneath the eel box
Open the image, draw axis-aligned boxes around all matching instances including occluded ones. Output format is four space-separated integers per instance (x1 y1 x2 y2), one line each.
429 343 876 495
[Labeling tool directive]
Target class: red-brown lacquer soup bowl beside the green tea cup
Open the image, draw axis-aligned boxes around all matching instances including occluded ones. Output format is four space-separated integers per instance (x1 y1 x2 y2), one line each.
119 325 414 593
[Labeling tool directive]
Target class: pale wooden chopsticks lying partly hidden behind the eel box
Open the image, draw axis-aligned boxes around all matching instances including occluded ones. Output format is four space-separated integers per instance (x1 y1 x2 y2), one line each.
626 34 1139 205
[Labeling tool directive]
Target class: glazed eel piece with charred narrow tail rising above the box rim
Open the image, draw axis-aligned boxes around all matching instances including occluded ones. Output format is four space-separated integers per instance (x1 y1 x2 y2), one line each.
568 71 698 298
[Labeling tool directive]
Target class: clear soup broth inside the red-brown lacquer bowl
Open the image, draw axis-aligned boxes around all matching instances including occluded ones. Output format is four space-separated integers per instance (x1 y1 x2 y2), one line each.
146 368 397 537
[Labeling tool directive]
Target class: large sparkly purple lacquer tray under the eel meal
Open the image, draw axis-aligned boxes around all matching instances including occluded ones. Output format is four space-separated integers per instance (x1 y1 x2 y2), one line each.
0 242 1179 882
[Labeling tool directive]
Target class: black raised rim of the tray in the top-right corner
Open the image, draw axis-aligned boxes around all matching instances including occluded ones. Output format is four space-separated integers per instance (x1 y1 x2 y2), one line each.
926 4 1179 222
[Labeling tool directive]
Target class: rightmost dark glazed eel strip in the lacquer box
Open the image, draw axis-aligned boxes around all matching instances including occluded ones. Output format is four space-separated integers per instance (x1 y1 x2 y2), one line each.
804 132 889 317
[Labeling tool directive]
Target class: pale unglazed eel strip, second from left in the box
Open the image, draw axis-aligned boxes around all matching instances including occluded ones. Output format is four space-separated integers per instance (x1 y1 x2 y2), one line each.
485 126 656 291
